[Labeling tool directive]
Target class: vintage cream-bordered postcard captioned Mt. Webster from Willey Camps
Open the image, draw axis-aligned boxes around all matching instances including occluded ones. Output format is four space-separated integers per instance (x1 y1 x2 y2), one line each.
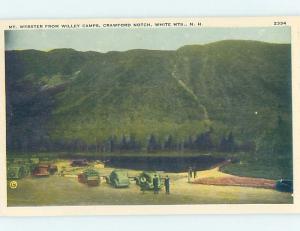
0 17 300 216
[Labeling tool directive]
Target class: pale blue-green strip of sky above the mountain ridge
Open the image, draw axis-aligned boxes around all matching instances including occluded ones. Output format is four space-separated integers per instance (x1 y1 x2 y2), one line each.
5 27 291 52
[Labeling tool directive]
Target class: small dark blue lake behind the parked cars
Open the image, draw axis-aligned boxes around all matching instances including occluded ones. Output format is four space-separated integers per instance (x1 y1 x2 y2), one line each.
106 155 225 172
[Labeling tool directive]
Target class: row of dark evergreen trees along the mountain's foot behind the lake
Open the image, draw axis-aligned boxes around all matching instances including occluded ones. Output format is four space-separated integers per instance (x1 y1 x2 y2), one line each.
9 131 255 153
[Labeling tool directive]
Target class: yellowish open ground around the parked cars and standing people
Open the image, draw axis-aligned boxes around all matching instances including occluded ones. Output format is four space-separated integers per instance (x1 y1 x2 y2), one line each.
8 161 293 206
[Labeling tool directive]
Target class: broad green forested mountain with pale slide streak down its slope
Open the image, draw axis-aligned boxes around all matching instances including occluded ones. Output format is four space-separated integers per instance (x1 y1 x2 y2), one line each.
5 40 291 152
